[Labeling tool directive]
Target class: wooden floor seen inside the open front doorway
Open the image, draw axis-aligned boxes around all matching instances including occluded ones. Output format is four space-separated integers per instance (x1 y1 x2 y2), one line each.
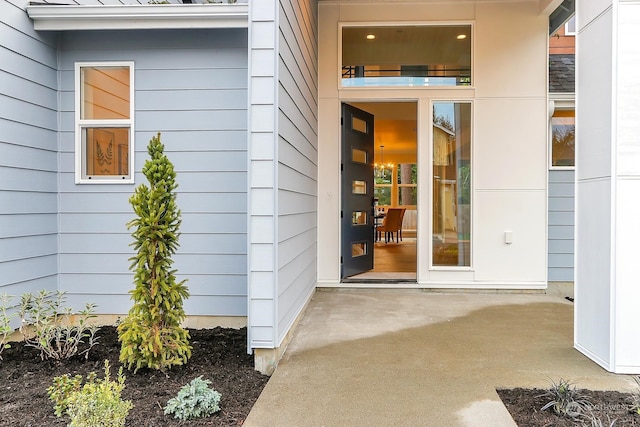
350 233 417 281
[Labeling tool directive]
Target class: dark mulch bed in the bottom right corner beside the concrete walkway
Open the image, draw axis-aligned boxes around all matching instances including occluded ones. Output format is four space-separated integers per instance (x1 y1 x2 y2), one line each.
497 388 640 427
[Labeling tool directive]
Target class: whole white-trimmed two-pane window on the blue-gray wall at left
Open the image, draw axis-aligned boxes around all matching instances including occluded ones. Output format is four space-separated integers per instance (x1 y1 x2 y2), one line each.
75 62 134 183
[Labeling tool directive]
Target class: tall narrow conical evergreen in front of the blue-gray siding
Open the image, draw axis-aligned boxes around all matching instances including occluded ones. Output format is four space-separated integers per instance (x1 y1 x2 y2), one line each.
118 134 191 372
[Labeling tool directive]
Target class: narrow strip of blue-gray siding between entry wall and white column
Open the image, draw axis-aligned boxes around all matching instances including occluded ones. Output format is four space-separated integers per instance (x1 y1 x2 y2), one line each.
548 170 575 282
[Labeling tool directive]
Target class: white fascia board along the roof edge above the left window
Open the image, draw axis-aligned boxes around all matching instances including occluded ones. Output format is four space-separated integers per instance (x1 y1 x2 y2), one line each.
27 4 249 31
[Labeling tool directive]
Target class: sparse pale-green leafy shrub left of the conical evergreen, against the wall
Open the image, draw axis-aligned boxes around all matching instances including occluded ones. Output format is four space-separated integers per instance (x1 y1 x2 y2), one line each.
18 290 99 360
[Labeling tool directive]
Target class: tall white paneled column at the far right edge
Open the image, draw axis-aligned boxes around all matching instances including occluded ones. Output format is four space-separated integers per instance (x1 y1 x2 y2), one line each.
575 0 640 374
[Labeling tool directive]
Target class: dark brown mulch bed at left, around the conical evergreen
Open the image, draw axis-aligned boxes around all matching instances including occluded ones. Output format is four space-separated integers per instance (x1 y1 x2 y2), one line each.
0 326 269 427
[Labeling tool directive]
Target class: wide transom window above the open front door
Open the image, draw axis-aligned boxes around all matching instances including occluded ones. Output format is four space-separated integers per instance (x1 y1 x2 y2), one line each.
342 25 471 87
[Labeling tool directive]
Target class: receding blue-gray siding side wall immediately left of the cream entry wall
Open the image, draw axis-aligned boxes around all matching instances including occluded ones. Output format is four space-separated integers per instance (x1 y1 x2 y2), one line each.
277 0 318 342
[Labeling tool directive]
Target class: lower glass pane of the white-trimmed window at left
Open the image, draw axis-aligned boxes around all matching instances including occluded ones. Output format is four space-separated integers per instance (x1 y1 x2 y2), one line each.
82 128 129 176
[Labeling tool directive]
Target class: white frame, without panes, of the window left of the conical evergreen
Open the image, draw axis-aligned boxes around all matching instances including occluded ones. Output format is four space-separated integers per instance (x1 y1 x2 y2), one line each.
74 61 135 184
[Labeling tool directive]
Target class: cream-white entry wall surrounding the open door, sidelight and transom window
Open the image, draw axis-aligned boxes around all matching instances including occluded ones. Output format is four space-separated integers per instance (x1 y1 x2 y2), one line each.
318 2 548 288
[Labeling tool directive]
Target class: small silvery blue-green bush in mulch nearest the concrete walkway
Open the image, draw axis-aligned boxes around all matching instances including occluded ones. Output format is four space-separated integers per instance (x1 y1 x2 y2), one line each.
164 376 222 420
